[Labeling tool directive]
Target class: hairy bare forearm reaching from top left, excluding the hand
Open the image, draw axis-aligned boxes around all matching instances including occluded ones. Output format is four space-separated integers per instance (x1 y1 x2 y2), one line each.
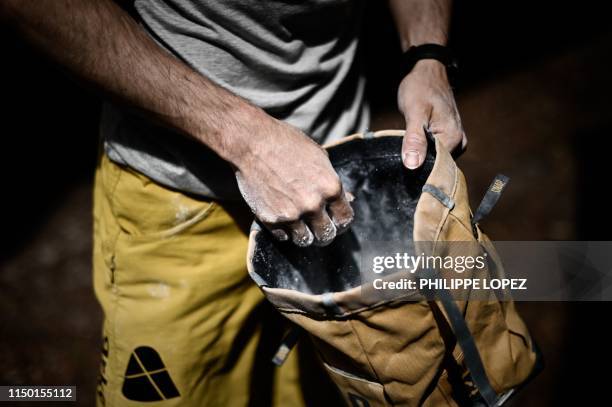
0 0 272 161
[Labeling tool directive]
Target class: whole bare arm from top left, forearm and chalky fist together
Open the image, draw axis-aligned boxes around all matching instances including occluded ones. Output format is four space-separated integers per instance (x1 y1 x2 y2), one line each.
0 0 353 246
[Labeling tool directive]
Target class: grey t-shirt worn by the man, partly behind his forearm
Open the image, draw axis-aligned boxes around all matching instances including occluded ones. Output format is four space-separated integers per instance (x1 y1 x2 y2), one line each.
101 0 369 199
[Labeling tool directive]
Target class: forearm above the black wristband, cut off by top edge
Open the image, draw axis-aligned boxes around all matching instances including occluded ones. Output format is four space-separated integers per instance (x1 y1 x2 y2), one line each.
389 0 452 51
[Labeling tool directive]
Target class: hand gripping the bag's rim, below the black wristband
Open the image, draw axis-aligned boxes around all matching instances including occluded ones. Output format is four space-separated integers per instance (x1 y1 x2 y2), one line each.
397 60 467 169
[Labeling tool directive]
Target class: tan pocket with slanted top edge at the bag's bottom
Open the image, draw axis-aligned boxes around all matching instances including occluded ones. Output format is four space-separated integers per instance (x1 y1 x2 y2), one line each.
323 362 390 407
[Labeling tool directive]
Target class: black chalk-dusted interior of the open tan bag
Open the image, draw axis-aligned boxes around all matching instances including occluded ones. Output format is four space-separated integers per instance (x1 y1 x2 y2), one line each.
252 136 435 294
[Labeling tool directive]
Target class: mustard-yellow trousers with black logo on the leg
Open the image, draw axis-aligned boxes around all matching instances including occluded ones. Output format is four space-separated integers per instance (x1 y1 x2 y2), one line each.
94 155 310 407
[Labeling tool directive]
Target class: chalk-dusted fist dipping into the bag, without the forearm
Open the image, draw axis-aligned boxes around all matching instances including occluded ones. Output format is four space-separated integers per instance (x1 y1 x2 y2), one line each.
232 116 353 247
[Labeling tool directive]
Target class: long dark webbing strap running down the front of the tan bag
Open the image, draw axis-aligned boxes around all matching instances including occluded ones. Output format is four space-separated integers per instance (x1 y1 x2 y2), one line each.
422 269 499 407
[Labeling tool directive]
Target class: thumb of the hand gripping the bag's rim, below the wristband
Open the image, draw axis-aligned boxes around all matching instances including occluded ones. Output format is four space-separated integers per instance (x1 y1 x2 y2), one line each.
402 105 429 170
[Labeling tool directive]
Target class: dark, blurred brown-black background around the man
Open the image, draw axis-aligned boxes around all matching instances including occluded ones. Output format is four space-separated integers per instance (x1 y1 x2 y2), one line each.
0 0 612 406
